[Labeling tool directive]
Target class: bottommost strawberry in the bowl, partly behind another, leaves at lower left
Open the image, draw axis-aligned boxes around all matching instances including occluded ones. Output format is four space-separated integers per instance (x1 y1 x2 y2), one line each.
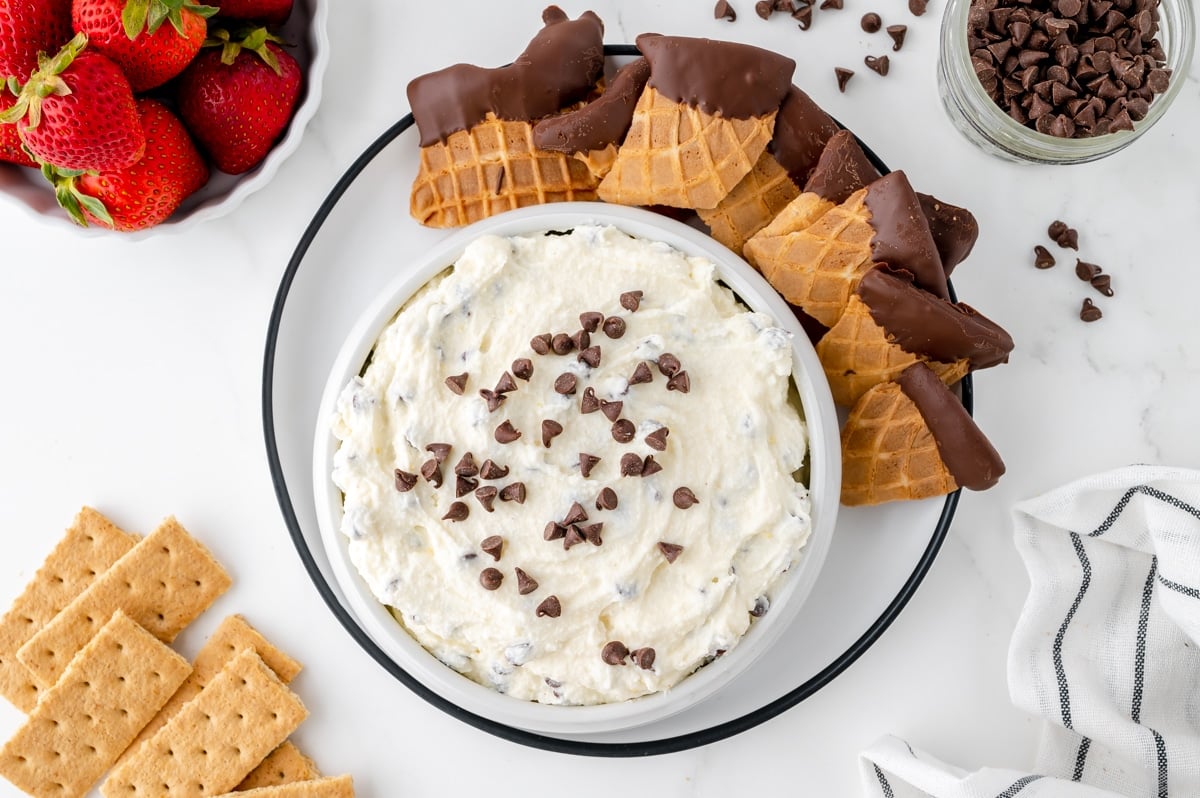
42 100 209 232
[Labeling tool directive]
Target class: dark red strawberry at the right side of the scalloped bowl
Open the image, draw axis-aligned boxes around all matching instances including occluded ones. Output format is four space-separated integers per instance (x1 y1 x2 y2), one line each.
178 28 302 174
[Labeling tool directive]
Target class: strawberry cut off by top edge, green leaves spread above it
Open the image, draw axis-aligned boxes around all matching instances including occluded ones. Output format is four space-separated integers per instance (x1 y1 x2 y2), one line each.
71 0 217 92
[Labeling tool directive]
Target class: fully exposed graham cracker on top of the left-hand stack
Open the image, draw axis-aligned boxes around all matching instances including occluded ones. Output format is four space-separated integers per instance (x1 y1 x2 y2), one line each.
0 611 192 798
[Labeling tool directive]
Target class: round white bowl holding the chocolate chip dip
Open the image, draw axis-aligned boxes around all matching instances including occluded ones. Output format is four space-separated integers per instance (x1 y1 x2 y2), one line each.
313 203 841 734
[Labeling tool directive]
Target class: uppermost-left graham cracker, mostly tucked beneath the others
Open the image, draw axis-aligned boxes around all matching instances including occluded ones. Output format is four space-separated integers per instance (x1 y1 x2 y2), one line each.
0 508 138 713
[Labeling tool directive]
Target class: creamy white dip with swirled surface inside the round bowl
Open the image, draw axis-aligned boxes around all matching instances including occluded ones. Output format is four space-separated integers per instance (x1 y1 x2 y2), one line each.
332 227 810 704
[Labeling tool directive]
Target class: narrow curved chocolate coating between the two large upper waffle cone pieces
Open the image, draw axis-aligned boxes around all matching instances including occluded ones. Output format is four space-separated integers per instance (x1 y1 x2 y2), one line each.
533 58 650 155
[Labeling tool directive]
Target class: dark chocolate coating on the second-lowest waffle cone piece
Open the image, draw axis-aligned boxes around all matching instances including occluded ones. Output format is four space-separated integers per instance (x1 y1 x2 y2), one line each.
858 268 1013 370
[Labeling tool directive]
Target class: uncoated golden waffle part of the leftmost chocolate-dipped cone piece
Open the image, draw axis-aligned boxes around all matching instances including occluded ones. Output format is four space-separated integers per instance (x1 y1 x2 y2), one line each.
409 113 596 227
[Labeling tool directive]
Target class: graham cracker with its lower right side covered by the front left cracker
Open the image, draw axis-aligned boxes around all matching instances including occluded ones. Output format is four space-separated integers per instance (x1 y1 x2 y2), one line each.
17 518 230 686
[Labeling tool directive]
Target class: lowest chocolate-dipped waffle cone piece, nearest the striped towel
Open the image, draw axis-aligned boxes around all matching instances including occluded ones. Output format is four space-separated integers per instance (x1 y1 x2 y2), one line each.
841 364 1004 506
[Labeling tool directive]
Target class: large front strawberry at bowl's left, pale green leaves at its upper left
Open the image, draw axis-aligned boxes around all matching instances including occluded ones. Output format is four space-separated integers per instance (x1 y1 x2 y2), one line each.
0 34 146 169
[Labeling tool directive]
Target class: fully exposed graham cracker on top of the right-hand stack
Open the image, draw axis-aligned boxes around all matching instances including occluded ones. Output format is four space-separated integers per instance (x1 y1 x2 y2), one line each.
101 650 308 798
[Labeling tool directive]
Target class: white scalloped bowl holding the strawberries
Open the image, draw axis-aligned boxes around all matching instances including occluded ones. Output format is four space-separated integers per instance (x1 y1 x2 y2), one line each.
0 0 329 240
